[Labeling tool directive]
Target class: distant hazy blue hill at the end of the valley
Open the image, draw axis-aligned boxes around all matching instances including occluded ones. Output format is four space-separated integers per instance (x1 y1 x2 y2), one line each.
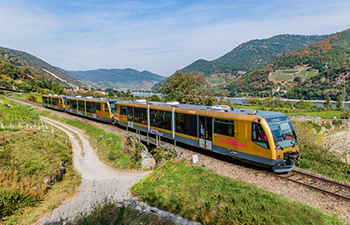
68 69 165 89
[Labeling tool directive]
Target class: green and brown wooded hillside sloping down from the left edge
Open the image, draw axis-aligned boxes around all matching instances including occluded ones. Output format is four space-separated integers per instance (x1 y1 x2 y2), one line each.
0 48 78 93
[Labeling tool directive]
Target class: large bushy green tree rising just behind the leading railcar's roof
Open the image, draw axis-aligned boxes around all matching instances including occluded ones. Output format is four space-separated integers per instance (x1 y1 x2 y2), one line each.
159 71 217 105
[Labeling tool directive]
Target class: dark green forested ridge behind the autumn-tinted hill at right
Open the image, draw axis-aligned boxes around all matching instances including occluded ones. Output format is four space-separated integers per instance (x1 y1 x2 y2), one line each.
182 34 327 76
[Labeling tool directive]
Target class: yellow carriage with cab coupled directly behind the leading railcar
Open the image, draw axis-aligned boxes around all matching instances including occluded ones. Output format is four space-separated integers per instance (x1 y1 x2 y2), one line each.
66 96 121 124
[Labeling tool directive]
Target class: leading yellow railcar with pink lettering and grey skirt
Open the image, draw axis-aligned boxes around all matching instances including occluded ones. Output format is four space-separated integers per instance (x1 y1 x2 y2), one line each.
116 101 299 173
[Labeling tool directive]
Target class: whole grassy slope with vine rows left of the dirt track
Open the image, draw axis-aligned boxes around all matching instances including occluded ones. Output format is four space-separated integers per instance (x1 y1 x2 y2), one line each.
0 96 78 224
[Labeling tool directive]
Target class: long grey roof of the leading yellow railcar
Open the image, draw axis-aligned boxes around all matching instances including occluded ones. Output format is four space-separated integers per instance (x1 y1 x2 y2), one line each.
117 100 286 119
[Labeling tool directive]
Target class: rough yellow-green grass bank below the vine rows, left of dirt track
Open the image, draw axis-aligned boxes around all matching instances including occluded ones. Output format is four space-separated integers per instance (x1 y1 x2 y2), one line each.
0 129 79 224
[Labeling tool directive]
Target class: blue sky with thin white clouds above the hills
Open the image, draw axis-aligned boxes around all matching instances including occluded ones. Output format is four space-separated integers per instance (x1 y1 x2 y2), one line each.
0 0 350 76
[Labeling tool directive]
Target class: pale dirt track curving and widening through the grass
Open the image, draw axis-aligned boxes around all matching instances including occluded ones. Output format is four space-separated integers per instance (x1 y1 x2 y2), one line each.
40 118 150 224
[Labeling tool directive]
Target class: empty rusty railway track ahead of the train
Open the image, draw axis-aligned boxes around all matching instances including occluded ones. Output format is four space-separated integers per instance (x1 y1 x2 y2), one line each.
276 169 350 202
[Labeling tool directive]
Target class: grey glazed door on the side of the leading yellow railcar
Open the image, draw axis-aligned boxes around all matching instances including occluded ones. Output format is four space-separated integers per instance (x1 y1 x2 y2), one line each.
198 116 213 150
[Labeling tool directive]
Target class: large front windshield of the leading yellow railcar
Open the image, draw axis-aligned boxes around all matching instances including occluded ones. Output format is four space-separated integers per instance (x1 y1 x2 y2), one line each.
267 116 297 149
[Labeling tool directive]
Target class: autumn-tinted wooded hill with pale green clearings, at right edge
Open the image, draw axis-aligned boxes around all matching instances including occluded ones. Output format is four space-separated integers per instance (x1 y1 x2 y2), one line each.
228 29 350 99
